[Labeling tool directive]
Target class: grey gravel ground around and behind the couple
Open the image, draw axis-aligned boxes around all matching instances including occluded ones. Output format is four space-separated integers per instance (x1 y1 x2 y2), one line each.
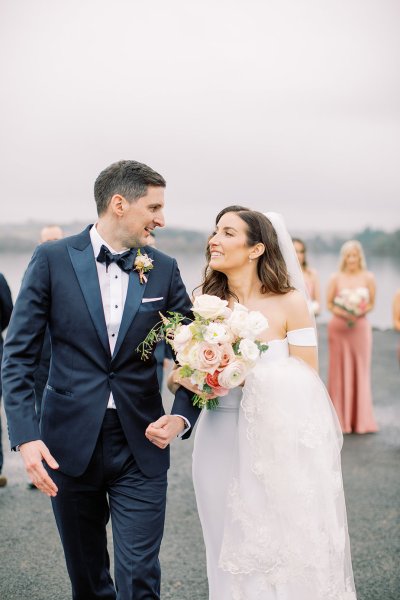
0 326 400 600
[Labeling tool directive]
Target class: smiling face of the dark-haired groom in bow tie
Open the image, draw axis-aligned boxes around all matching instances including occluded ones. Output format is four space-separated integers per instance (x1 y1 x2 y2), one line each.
121 186 165 248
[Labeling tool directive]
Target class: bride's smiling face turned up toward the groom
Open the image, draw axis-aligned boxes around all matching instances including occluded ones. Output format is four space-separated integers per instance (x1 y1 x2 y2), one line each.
208 213 253 273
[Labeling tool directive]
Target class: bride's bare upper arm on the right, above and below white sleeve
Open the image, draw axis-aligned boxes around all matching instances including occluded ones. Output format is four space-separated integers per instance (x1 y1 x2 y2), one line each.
285 290 318 371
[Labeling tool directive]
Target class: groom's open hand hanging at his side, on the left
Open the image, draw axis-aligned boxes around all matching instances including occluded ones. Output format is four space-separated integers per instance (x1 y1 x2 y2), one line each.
19 440 58 497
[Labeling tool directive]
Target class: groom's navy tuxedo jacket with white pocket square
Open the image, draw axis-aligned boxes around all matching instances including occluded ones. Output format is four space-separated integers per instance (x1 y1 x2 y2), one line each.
2 226 199 477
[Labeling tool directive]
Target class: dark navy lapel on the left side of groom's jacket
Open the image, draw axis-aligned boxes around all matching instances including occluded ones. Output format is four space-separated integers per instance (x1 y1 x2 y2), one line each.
68 228 111 358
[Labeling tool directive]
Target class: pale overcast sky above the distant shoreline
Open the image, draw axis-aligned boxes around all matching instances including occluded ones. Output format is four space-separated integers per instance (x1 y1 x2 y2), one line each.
0 0 400 232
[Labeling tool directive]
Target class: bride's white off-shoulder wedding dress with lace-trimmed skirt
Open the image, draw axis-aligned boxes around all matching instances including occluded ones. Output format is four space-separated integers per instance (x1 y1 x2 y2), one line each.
193 328 356 600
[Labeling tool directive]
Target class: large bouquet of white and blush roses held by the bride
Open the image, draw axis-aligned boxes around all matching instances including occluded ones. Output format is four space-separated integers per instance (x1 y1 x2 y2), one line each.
138 294 268 409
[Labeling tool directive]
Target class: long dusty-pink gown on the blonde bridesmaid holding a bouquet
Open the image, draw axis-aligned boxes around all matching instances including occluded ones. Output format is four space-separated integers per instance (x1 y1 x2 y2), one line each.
328 288 378 433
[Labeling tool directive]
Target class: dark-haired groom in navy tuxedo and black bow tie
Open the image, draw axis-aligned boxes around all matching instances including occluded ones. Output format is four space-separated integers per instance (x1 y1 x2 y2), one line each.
3 161 198 600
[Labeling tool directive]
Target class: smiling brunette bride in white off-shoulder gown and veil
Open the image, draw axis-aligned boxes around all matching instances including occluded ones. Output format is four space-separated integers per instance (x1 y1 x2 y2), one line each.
170 206 356 600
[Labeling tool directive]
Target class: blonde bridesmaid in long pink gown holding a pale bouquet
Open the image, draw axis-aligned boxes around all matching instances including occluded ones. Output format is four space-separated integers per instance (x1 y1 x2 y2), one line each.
327 240 378 433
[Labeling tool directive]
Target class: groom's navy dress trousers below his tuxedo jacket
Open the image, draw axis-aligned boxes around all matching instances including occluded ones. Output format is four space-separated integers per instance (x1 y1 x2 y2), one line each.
49 409 167 600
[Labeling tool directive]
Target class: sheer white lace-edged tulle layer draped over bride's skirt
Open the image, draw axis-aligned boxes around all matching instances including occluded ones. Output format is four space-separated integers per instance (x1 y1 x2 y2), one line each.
220 358 356 600
